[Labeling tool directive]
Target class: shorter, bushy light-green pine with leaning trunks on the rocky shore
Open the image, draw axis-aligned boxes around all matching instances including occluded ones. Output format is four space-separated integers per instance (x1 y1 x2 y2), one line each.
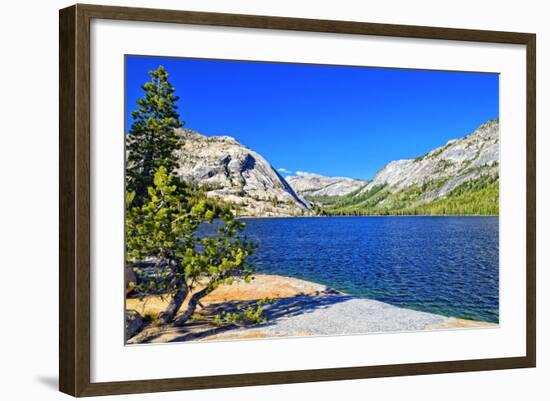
126 167 256 325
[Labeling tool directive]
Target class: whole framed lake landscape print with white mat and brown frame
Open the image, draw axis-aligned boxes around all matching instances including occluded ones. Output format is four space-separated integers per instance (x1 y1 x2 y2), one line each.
59 5 536 396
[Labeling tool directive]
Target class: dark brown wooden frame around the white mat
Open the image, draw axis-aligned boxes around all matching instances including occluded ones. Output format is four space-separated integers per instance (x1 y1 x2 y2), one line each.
59 4 536 396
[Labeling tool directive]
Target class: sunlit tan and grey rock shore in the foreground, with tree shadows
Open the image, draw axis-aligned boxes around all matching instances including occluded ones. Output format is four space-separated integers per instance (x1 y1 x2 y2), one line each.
126 274 497 344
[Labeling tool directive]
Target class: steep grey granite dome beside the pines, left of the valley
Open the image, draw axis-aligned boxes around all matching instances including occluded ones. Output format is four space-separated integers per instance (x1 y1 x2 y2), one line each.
176 129 310 216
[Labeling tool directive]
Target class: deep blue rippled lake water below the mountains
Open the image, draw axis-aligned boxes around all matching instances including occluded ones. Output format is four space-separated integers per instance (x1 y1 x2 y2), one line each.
243 217 499 322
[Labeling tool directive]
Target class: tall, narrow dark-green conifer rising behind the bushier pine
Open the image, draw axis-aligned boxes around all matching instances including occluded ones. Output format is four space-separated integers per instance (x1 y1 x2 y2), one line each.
126 66 183 205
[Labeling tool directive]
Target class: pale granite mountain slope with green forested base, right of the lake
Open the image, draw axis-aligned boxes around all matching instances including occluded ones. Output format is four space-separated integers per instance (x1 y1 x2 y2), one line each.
308 120 499 214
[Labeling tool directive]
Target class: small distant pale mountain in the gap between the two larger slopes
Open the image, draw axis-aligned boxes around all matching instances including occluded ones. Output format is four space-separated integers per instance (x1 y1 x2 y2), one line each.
286 173 367 197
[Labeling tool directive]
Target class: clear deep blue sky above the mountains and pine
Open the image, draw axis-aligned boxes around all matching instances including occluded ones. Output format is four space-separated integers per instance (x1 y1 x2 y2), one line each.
126 56 499 179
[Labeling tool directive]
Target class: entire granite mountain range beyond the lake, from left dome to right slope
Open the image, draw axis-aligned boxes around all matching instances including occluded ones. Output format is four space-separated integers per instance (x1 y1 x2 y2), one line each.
172 119 499 217
